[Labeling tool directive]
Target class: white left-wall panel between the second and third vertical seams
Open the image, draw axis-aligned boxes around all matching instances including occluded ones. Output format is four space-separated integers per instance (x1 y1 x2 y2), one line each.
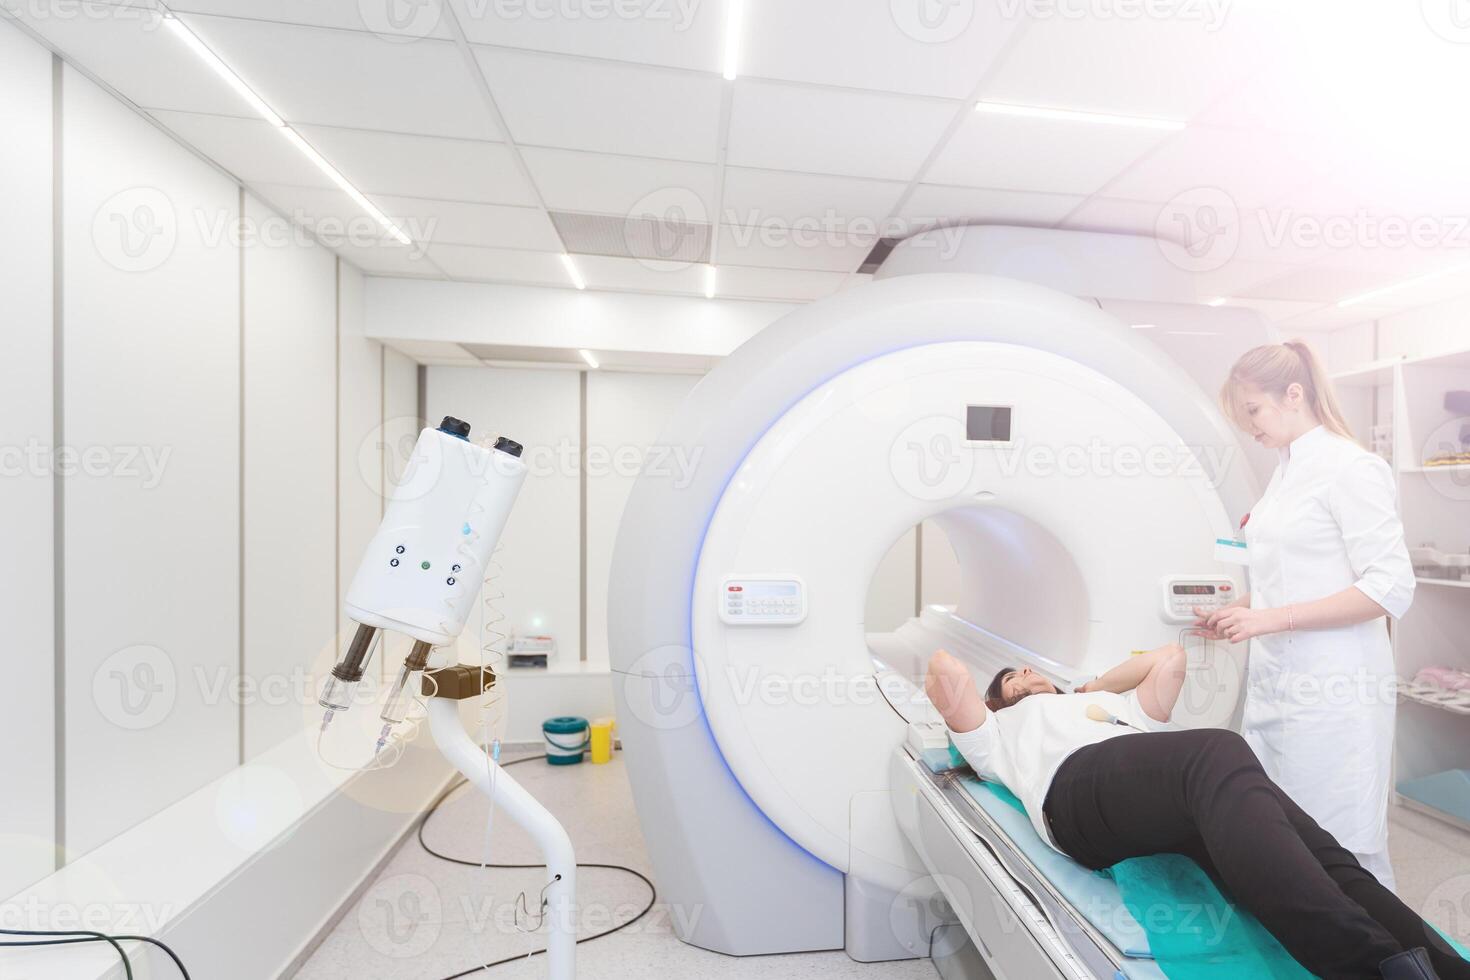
244 197 337 760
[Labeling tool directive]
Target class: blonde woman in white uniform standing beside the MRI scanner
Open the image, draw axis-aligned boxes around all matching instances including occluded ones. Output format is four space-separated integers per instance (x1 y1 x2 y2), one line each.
1197 341 1414 889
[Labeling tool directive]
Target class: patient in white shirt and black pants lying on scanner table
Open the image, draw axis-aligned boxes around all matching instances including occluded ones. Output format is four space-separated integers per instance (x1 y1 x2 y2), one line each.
925 645 1470 980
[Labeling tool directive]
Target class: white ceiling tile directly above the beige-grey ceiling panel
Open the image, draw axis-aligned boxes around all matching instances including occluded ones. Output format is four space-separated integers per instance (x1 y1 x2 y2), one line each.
520 147 714 222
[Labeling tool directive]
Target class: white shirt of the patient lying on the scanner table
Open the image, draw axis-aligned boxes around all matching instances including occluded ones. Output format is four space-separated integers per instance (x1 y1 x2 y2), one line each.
950 691 1173 852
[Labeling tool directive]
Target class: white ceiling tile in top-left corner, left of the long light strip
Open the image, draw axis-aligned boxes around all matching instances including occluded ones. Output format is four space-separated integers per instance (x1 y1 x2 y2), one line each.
0 0 264 116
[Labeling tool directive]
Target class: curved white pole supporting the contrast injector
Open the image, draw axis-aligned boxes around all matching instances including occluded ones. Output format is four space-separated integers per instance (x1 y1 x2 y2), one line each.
428 698 576 980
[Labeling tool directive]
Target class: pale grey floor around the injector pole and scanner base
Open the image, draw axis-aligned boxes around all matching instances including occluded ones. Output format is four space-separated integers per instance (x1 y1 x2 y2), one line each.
295 758 1470 980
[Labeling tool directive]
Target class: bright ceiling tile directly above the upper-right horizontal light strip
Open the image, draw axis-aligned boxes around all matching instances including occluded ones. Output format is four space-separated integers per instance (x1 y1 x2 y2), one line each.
982 3 1261 120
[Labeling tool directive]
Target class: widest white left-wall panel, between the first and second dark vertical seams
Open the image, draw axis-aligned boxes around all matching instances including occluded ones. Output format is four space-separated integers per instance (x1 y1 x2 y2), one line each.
62 69 240 851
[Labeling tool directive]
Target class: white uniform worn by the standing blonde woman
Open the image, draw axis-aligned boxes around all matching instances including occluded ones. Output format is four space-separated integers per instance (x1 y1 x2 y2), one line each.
1242 426 1414 855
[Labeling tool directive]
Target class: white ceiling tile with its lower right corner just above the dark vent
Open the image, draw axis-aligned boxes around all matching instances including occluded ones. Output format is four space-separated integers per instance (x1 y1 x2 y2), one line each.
720 167 907 232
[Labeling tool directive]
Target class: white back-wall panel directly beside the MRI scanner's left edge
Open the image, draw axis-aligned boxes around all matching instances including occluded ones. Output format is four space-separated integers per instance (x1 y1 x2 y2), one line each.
585 370 700 670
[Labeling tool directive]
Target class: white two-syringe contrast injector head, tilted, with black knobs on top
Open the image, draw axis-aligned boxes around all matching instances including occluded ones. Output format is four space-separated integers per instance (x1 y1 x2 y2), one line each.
319 416 526 734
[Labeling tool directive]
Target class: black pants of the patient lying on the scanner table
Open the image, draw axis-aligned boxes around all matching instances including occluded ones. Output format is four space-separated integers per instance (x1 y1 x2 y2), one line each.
1044 729 1470 980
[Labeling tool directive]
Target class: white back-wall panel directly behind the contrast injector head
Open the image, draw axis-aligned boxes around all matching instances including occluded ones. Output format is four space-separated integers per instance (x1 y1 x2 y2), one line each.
426 367 581 664
